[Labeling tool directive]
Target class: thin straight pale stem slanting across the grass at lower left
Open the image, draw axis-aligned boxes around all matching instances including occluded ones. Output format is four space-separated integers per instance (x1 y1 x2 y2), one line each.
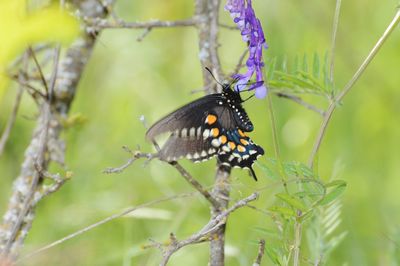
17 193 195 262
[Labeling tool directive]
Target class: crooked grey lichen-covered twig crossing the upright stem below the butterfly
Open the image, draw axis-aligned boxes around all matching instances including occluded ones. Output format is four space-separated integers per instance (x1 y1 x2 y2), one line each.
160 193 258 265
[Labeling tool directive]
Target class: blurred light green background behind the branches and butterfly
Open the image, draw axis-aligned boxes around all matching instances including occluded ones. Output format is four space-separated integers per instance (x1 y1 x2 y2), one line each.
0 0 400 265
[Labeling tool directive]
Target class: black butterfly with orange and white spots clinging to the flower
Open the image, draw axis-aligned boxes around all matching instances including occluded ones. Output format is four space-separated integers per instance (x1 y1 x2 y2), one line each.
146 84 264 180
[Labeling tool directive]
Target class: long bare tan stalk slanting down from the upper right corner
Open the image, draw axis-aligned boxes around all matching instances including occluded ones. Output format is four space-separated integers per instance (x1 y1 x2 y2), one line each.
308 9 400 167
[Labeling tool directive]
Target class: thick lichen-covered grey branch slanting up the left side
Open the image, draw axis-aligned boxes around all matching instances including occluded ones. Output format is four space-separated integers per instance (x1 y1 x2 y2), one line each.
0 0 113 259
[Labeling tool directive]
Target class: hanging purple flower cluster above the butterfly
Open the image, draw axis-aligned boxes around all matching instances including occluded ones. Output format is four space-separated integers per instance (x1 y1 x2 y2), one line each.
225 0 268 98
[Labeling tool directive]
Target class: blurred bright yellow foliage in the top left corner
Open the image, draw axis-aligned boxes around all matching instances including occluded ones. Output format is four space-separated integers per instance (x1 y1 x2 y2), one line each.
0 0 79 95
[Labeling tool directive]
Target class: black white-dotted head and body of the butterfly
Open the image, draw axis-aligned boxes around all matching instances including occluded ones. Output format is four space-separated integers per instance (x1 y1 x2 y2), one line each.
222 84 254 132
